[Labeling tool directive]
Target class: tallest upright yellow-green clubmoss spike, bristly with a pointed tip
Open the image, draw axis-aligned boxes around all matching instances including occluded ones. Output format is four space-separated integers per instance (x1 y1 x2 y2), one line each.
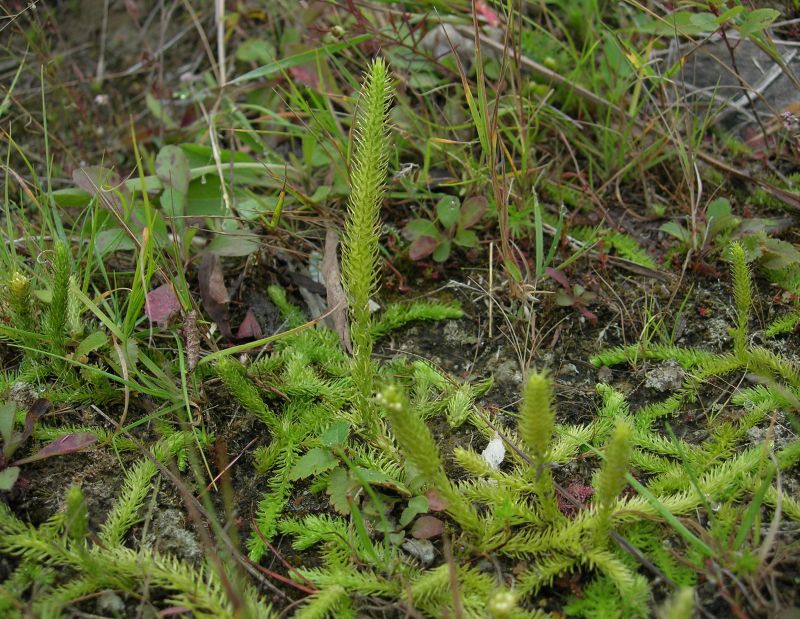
342 58 391 433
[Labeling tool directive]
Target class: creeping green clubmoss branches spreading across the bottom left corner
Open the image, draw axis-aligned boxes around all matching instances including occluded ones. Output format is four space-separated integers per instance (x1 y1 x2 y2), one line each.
0 433 274 619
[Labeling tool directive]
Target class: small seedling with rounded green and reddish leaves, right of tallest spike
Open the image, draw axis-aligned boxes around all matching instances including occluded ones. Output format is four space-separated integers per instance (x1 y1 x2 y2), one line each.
405 196 486 262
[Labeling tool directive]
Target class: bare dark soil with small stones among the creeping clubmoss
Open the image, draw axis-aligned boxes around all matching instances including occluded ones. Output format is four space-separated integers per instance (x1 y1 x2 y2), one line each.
0 245 800 608
